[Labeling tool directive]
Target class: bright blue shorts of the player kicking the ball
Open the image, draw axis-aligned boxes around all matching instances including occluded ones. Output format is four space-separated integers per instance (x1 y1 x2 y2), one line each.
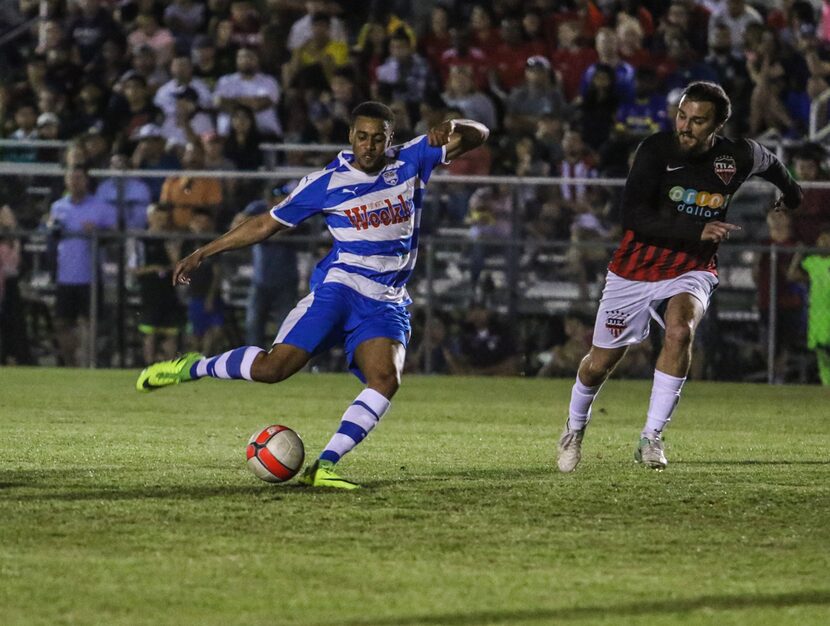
274 283 412 383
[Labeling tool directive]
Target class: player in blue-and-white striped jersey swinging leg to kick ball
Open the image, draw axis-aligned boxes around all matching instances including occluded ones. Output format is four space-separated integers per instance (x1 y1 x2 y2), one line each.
136 102 489 489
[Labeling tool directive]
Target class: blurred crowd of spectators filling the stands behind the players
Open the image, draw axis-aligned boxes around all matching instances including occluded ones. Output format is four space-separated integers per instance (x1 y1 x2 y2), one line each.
0 0 830 378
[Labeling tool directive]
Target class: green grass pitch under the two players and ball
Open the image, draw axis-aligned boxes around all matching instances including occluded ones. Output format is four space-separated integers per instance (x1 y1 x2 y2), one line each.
0 368 830 626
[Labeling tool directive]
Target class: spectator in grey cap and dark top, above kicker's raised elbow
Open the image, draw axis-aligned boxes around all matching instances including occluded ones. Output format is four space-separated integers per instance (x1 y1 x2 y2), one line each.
504 55 567 133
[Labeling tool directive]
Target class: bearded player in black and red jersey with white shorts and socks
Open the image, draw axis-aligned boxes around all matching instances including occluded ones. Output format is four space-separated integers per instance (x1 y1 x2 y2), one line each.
558 82 802 472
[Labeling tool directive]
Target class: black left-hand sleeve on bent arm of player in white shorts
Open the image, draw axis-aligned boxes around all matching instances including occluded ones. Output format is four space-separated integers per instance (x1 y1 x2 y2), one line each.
622 139 703 241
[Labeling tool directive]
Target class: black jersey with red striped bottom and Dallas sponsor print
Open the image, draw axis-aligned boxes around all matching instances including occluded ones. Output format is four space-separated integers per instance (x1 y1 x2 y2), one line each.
608 132 801 281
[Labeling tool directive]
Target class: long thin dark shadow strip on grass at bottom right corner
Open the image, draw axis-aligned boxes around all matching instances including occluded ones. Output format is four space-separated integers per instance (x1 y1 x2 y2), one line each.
339 590 830 626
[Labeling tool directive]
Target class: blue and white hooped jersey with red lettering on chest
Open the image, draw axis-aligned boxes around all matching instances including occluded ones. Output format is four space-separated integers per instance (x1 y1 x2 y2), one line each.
271 135 446 305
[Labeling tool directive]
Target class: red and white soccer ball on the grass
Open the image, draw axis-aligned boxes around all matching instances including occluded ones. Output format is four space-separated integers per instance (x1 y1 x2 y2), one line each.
246 424 305 483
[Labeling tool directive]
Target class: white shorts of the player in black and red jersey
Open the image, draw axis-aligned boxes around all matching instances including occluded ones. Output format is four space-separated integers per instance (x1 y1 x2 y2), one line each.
593 271 718 348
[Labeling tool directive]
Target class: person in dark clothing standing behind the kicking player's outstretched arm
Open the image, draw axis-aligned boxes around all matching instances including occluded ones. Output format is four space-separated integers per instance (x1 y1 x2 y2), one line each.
231 181 299 346
